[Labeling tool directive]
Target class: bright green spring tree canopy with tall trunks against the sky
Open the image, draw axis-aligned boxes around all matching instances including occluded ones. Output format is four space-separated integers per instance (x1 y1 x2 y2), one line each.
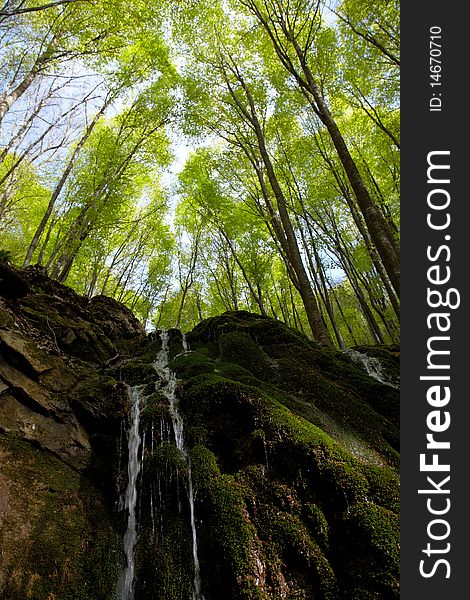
0 0 400 349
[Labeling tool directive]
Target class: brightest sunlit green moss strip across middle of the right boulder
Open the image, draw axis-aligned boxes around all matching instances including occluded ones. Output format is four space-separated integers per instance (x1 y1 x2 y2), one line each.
182 366 393 512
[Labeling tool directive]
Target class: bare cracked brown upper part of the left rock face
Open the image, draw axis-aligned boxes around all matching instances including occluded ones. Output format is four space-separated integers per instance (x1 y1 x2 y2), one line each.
0 268 145 471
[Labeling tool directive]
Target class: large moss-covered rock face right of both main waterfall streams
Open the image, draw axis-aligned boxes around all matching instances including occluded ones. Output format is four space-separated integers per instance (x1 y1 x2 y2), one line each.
172 312 399 600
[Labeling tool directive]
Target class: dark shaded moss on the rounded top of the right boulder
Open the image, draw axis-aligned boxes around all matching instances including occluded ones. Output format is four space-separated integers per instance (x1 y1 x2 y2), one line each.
181 312 399 466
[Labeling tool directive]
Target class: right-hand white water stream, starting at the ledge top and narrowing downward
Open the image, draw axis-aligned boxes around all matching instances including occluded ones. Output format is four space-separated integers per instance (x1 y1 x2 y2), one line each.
153 331 204 600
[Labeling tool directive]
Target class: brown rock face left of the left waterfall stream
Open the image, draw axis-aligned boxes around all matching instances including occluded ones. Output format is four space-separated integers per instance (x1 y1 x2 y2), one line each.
0 265 145 600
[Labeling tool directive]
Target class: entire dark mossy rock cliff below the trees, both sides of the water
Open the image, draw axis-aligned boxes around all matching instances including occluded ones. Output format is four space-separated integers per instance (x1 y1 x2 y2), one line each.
0 266 399 600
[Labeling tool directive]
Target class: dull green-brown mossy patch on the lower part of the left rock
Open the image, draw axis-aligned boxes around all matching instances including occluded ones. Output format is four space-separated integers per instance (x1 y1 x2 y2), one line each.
1 437 120 600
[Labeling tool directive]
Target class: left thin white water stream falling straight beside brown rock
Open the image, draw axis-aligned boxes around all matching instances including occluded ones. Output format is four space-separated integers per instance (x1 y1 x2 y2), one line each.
118 386 142 600
